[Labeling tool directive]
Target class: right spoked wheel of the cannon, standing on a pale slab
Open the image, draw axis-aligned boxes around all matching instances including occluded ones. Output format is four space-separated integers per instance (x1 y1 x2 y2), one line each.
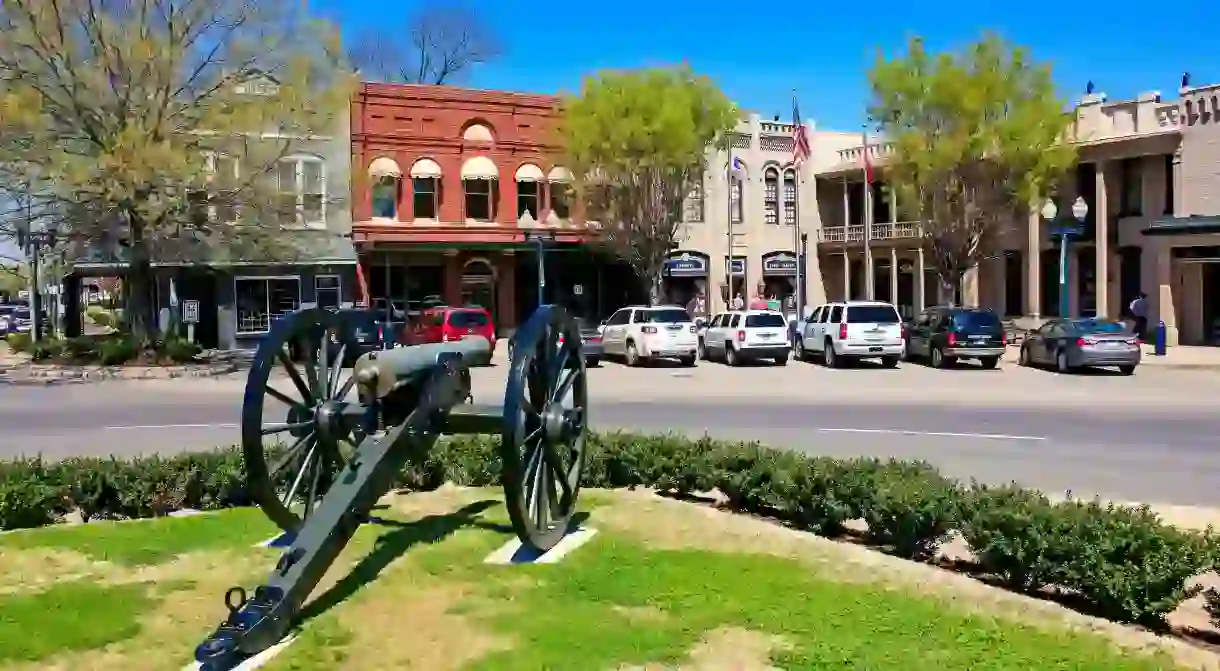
500 305 588 551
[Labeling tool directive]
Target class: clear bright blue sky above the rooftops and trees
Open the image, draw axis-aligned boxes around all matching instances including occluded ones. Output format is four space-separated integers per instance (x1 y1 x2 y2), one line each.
312 0 1220 131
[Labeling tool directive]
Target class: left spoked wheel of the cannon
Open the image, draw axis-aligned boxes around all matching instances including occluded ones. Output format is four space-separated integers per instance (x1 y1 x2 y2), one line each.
242 307 361 533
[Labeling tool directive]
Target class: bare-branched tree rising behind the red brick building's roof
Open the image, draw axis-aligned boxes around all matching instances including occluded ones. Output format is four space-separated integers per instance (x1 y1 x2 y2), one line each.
351 0 500 84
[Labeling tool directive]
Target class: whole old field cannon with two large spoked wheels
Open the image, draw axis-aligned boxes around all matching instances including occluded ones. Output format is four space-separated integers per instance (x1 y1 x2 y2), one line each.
195 305 588 671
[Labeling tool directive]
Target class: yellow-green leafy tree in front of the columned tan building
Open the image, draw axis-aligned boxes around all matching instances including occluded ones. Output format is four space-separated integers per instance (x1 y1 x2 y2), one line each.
869 35 1076 300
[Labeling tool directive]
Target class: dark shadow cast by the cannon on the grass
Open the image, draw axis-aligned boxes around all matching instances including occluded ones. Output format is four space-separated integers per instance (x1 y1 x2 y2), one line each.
296 500 500 626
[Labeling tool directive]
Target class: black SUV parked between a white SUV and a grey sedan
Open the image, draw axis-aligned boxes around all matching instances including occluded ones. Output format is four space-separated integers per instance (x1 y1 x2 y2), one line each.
906 307 1005 368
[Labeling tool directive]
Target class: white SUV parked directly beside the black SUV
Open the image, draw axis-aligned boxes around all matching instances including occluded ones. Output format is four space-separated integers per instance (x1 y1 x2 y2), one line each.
792 300 905 368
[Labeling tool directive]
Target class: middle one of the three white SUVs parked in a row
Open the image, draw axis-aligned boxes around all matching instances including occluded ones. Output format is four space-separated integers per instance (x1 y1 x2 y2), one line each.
699 310 791 366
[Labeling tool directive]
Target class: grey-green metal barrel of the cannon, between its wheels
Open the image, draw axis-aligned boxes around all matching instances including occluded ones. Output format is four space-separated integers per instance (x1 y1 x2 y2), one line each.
353 336 492 399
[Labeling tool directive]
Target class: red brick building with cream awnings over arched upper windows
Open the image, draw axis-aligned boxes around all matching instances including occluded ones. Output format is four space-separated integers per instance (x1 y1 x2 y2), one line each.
351 83 615 329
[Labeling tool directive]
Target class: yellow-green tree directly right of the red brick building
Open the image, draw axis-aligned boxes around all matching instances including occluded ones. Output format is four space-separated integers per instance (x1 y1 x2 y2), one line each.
561 67 738 301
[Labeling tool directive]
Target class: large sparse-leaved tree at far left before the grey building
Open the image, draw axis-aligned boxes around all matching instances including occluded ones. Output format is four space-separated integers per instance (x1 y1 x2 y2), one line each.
0 0 351 343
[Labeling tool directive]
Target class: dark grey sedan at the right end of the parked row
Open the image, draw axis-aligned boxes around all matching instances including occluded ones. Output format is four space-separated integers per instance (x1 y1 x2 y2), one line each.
1020 318 1141 375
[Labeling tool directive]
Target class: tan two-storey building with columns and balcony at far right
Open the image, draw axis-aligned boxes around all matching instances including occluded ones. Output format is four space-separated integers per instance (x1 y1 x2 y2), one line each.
802 78 1220 344
